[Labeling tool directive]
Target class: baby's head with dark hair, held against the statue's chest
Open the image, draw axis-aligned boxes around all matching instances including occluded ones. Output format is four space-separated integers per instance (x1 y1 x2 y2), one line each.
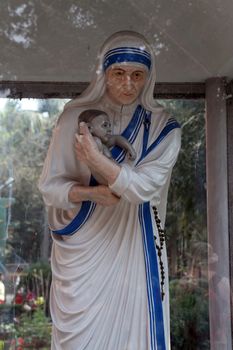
78 109 112 142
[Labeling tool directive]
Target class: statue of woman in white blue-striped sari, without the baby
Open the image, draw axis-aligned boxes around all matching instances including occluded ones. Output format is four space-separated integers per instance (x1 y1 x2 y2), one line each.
39 31 180 350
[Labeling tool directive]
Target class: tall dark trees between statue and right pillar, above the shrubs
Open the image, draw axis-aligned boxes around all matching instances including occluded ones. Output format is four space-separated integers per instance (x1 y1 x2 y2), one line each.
163 100 207 277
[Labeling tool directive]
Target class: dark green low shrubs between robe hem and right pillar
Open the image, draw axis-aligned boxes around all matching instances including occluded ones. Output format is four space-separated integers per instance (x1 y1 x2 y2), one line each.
170 279 209 350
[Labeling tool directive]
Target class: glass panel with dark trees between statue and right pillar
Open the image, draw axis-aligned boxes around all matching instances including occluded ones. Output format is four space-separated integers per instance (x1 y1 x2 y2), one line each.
162 100 210 350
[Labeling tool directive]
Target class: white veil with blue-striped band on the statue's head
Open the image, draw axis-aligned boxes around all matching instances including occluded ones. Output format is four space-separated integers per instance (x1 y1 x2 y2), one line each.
65 31 162 111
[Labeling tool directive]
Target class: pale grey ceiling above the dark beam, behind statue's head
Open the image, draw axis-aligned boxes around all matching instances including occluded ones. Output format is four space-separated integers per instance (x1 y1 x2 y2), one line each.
0 0 233 82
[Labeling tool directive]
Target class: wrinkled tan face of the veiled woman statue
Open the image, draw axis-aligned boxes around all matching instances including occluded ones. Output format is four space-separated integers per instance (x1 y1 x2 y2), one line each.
105 64 148 105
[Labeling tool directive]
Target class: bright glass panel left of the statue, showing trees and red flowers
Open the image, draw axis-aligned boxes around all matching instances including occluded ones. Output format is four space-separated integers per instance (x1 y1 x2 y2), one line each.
0 99 66 349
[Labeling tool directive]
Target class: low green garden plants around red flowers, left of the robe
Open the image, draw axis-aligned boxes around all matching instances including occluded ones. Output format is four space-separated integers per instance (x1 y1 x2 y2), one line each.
0 262 51 349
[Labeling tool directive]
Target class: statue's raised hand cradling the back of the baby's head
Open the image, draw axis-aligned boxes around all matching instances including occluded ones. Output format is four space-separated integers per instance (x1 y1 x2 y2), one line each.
75 122 99 164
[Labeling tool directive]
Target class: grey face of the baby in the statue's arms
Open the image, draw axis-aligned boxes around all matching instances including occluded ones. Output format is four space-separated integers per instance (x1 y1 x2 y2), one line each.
89 114 112 141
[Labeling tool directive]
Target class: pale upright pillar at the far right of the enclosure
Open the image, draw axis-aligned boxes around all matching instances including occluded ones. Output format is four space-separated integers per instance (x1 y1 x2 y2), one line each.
206 78 232 350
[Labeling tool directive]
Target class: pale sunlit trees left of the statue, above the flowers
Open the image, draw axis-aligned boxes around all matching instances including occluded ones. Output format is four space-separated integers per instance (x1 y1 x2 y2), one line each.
0 100 64 262
